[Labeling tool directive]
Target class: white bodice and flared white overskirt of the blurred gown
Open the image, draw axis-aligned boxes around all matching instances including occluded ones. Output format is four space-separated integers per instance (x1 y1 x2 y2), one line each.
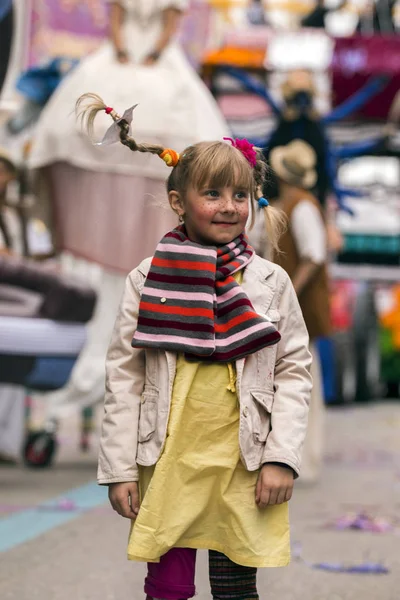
29 0 228 179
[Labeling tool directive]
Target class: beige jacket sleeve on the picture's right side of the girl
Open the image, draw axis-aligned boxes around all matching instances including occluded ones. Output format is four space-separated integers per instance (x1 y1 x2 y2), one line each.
263 270 312 477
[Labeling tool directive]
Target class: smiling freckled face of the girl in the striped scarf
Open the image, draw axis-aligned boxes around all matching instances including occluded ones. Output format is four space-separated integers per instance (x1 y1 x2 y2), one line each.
169 187 250 246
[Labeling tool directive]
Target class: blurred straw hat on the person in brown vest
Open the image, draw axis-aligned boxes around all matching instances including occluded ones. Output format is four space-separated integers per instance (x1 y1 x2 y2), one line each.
269 140 317 189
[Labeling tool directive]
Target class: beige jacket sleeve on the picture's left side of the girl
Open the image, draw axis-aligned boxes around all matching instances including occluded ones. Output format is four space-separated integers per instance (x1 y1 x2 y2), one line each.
97 270 145 484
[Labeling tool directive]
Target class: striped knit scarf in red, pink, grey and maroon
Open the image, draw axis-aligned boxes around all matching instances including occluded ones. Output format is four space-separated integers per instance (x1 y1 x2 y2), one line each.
132 226 280 362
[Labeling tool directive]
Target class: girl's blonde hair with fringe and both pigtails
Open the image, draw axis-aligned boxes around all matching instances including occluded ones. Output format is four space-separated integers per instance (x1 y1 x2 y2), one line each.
76 94 286 251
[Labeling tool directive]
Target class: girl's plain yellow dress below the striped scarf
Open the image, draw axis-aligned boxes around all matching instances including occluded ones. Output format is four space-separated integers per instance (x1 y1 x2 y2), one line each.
128 280 290 567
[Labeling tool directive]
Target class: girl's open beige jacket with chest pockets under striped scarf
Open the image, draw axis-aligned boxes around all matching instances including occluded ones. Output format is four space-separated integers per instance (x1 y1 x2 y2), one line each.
98 256 312 484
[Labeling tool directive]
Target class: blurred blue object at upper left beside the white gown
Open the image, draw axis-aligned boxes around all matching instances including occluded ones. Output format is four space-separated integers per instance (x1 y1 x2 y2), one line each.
16 56 79 106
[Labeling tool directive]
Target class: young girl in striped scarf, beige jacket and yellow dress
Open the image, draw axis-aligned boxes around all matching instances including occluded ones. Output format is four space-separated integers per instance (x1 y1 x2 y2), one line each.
81 99 311 600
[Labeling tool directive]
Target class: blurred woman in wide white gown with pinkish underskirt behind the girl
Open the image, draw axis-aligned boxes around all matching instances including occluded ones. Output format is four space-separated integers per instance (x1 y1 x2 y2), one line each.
30 0 229 422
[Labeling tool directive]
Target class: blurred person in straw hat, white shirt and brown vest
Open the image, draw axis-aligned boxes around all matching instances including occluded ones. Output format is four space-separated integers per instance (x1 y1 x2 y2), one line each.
260 139 331 482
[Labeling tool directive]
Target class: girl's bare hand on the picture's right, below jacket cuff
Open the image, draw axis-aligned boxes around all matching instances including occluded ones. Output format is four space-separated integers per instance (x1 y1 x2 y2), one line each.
256 464 294 508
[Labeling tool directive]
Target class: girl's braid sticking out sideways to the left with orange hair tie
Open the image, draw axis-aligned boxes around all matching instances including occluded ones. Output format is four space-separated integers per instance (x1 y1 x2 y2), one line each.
75 94 179 167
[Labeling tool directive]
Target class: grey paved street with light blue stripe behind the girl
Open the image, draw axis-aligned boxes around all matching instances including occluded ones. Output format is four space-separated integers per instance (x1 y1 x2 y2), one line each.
0 402 400 600
